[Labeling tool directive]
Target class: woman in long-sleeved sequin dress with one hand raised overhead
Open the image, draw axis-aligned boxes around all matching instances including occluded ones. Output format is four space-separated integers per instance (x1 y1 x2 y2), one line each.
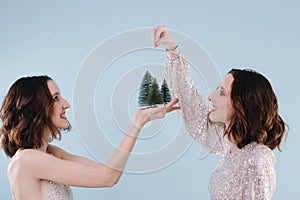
152 26 286 200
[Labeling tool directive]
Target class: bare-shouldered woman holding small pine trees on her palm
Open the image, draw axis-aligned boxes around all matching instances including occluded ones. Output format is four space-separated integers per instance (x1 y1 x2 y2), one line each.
1 76 179 200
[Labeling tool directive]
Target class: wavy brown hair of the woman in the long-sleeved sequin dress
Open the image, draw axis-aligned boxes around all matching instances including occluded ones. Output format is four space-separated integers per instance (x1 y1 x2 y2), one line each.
224 69 286 151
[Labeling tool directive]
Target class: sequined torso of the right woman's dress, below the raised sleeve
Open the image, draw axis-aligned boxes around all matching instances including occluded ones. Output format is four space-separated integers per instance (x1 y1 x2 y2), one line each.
208 142 276 200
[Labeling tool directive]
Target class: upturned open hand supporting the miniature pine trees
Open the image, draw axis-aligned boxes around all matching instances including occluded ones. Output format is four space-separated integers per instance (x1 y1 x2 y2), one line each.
132 98 180 128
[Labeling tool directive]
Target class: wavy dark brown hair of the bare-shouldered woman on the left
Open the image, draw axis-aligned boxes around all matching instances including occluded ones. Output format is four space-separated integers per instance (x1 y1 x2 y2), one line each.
0 76 61 157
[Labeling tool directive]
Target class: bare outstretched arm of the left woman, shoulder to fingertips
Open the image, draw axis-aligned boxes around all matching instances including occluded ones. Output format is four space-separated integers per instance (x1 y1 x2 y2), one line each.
8 99 179 187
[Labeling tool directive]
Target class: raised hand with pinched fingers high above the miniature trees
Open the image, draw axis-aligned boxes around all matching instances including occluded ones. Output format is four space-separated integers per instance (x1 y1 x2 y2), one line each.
152 26 176 49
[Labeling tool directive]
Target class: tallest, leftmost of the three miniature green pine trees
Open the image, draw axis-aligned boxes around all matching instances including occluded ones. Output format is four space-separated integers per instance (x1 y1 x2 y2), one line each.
139 71 153 106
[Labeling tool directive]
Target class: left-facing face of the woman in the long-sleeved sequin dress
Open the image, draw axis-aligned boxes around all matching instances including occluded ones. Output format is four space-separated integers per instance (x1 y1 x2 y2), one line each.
208 74 234 125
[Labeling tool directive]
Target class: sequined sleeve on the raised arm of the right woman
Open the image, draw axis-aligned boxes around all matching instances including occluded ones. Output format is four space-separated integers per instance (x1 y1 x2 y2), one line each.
166 55 229 155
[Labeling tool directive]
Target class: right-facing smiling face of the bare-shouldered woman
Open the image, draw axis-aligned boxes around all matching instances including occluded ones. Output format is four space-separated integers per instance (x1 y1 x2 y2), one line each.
47 80 70 129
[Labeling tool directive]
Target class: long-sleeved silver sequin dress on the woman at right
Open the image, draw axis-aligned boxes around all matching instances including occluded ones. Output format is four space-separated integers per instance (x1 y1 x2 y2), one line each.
166 55 276 200
